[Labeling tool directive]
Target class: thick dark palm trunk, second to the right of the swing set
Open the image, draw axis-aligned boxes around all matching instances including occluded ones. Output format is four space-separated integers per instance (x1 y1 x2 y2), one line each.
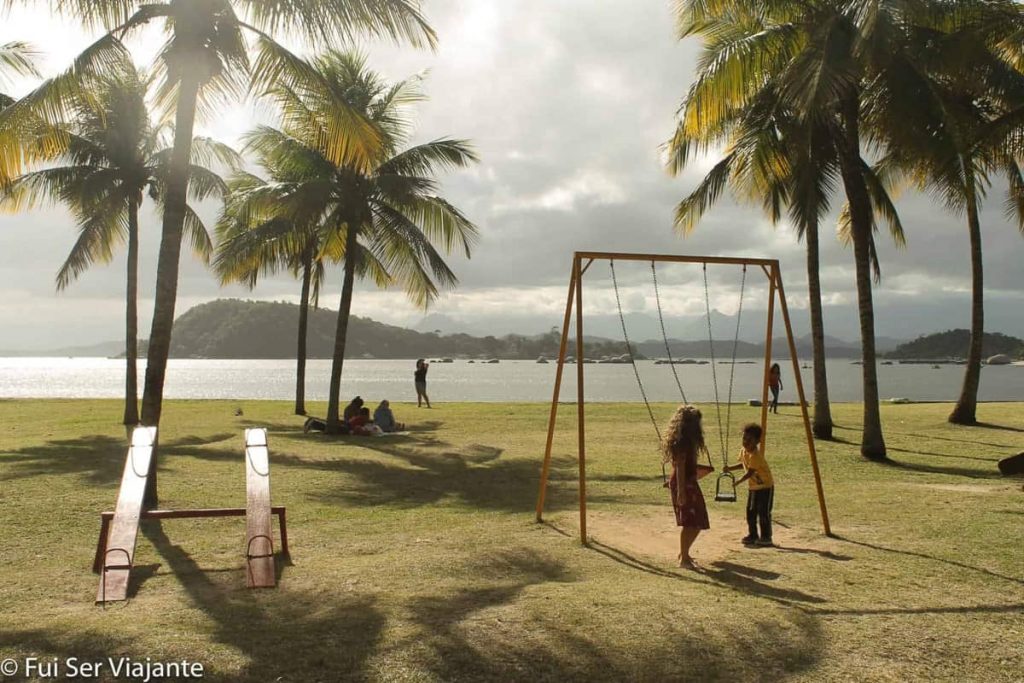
841 97 886 460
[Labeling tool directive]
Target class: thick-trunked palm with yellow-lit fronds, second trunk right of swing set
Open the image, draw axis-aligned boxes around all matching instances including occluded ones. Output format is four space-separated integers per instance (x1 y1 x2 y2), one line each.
677 0 908 460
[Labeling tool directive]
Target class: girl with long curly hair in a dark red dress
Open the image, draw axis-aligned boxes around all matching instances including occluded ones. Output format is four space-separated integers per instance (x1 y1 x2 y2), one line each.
662 405 715 569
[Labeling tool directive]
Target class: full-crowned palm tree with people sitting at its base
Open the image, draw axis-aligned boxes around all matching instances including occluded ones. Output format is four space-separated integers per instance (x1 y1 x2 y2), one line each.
247 51 476 431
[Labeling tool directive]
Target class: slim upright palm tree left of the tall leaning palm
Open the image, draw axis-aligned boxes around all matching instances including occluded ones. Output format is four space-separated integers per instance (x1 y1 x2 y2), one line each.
0 62 238 425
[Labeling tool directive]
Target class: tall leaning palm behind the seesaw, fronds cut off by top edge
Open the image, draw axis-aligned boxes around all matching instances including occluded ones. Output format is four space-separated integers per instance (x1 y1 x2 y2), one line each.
7 0 436 507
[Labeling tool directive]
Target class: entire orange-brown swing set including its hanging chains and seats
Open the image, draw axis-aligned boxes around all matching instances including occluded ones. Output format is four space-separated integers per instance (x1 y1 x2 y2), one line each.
537 252 831 546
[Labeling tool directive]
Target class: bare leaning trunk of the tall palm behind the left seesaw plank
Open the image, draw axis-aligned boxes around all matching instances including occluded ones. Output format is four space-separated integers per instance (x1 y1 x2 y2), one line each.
142 76 200 507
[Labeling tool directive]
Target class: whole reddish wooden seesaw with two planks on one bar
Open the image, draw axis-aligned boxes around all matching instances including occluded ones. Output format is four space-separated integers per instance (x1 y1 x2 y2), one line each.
92 427 289 605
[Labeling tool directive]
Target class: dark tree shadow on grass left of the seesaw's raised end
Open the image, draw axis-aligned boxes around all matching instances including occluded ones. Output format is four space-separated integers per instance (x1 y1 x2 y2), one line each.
0 434 128 484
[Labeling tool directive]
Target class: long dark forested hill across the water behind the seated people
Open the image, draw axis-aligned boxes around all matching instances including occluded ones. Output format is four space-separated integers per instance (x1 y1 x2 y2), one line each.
171 299 625 359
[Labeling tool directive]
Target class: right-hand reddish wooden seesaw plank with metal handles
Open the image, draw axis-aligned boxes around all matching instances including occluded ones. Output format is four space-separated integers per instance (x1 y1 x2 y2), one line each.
246 429 276 588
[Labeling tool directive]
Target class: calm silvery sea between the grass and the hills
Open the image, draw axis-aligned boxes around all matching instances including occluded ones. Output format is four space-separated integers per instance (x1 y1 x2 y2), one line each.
0 357 1024 402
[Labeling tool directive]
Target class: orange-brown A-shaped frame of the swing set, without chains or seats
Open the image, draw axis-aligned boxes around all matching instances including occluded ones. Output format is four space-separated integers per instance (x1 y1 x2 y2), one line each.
537 251 831 546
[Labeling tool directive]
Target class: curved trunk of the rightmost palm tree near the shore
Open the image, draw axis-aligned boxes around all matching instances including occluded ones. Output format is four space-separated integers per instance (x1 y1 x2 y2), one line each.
948 163 985 425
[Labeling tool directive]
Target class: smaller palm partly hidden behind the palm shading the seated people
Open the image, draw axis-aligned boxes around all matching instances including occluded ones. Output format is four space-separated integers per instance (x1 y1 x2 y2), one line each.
214 171 338 415
